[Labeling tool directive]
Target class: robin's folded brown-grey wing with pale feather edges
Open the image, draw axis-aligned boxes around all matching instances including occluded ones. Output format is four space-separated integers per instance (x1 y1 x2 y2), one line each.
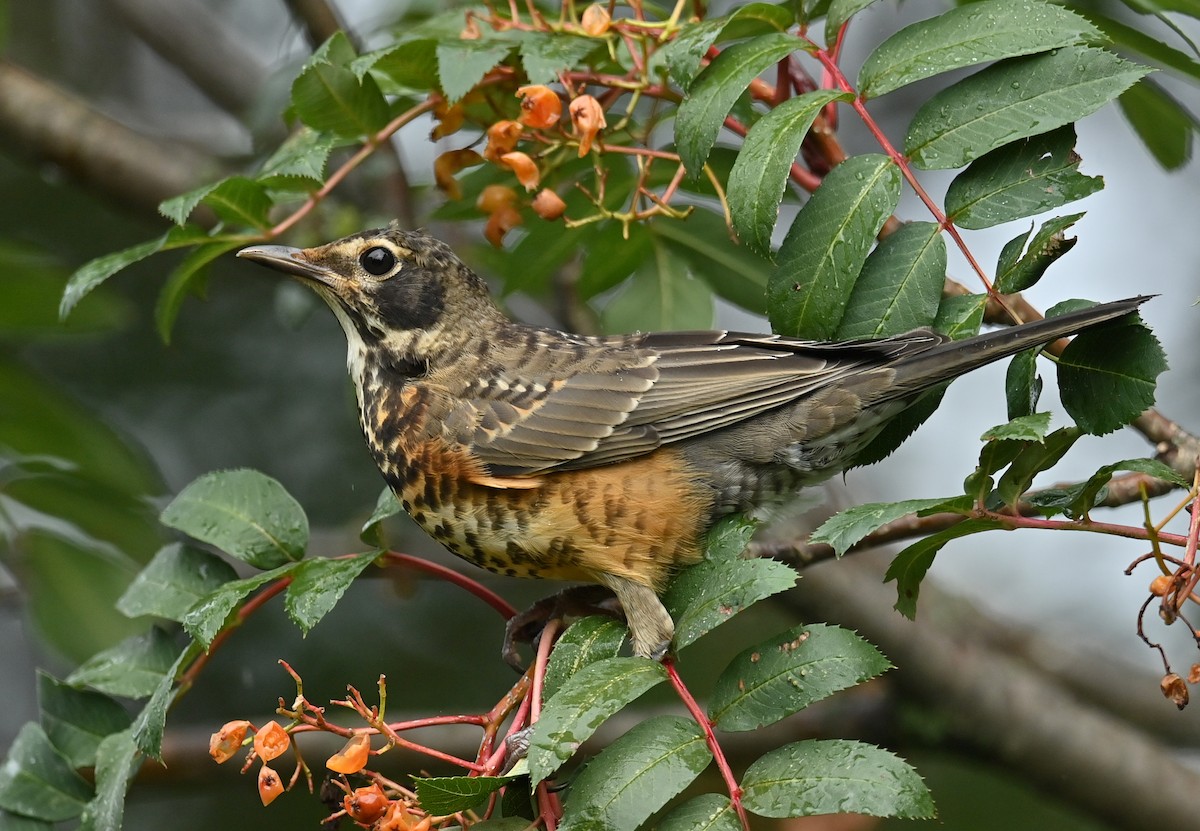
446 331 944 477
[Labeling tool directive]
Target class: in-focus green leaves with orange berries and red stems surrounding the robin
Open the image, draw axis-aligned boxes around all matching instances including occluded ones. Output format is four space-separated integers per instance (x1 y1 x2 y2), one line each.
0 0 1200 829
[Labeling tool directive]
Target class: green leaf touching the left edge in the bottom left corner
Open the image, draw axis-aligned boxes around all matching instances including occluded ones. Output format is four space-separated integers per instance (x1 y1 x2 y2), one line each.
0 722 91 823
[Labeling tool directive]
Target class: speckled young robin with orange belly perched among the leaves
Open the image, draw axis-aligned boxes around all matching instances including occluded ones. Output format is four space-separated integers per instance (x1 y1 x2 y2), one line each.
238 223 1146 657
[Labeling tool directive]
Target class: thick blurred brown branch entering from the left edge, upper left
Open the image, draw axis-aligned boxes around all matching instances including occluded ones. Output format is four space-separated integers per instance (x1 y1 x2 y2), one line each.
0 60 218 216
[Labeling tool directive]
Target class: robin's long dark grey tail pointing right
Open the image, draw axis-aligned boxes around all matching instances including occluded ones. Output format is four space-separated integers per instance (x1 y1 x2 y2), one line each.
893 295 1152 397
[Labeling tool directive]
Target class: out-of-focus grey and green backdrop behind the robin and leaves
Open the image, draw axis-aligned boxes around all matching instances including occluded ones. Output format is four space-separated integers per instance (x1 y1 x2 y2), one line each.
0 0 1200 830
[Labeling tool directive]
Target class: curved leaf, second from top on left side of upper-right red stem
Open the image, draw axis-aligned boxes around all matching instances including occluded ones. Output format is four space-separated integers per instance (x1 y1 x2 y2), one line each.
728 90 853 255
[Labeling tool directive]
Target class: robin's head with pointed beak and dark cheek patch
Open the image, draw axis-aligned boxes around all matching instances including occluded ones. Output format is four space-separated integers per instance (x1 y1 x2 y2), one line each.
238 223 499 372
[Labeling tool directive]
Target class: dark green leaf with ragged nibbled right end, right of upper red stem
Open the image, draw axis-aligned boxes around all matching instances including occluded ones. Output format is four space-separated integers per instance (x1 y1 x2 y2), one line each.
946 124 1104 229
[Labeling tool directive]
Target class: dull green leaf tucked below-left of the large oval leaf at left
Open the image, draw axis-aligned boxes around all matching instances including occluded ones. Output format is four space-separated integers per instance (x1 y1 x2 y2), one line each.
116 543 238 621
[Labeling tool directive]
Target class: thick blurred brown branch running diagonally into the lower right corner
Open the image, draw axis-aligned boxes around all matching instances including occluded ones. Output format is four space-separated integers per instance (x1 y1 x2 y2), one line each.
782 560 1200 830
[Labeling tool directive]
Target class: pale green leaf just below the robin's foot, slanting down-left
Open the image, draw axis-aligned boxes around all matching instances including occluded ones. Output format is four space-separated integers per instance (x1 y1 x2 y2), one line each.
527 658 667 784
